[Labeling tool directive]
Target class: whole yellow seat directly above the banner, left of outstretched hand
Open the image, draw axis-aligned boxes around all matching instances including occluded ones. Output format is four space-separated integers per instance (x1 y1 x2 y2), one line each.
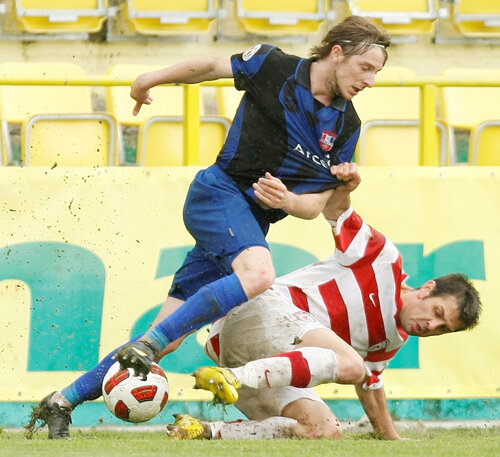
22 114 118 167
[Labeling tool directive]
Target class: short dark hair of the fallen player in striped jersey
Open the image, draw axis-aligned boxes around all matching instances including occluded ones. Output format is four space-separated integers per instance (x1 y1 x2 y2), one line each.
429 273 481 331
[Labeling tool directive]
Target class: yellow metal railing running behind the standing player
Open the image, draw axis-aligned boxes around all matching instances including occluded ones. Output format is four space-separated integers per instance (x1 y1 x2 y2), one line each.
0 75 500 166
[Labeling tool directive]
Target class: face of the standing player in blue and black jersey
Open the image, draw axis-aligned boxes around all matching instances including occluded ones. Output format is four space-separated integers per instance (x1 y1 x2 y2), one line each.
330 46 385 100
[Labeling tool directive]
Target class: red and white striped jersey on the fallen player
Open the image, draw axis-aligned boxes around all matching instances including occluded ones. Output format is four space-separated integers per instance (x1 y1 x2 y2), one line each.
273 207 408 389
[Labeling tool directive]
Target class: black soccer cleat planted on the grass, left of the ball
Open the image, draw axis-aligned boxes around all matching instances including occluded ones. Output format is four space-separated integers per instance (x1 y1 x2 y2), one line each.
24 392 72 440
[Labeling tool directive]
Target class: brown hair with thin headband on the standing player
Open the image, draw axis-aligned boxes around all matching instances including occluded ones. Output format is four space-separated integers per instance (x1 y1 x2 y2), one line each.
309 16 391 63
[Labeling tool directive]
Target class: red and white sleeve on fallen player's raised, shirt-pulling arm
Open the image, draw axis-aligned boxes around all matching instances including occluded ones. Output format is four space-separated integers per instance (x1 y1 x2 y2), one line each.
332 207 386 268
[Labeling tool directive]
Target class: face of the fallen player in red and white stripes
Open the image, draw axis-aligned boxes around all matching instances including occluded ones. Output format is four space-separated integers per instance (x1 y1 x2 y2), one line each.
400 284 461 337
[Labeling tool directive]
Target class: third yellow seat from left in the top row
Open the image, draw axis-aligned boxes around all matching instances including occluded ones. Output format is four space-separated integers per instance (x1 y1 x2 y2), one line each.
236 0 329 35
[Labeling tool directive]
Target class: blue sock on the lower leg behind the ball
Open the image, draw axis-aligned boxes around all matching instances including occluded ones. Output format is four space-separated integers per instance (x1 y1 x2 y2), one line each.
61 335 142 407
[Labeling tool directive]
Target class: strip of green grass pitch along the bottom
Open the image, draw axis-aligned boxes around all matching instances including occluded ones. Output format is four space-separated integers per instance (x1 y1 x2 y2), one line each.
0 428 500 457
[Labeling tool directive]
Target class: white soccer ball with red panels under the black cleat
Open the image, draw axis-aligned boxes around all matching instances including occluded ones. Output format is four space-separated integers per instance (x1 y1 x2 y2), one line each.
102 362 168 422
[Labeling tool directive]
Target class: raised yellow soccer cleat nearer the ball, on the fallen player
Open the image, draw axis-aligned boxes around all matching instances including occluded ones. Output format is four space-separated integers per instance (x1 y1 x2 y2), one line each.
193 367 241 405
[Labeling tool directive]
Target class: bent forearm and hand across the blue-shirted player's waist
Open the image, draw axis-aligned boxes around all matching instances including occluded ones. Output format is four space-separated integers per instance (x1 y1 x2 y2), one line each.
253 173 333 219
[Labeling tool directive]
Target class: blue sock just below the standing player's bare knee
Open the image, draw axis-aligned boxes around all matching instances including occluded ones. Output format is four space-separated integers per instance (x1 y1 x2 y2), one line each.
146 273 248 348
